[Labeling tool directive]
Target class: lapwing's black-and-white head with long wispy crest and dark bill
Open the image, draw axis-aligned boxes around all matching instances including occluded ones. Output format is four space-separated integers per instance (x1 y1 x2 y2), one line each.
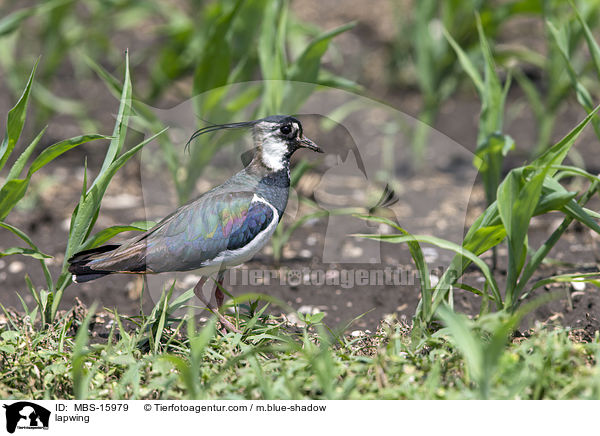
188 115 323 171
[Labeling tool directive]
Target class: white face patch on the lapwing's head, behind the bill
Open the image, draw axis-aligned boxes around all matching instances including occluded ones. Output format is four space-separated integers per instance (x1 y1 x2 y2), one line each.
256 121 300 171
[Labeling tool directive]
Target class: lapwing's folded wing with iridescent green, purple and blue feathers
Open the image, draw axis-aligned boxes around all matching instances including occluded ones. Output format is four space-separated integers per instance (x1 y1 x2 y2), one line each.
69 191 275 282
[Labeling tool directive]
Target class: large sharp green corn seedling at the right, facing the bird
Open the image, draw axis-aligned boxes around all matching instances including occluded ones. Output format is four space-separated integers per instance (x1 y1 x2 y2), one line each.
358 108 600 325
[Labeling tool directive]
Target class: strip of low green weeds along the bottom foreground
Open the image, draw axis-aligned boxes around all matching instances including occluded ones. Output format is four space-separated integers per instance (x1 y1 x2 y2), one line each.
0 296 600 399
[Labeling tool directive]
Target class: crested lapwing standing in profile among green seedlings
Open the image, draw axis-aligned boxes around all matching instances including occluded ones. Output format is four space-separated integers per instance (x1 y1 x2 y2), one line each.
69 115 323 331
